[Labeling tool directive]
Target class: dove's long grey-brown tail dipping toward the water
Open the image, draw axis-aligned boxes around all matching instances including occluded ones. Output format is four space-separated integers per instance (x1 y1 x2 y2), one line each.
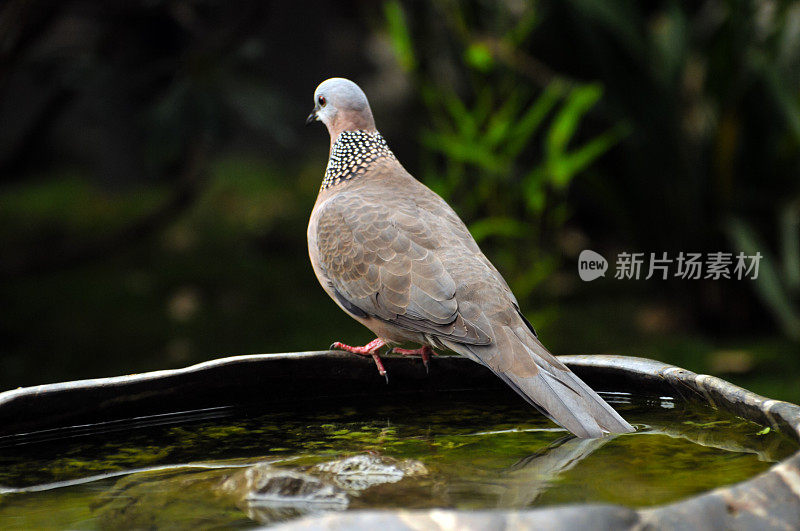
440 326 634 438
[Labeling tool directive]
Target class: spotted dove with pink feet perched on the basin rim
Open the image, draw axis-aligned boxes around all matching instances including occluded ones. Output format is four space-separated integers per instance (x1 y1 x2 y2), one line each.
306 78 633 438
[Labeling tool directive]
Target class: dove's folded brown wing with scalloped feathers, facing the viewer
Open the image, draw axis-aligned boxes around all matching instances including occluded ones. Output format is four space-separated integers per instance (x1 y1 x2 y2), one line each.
316 190 491 345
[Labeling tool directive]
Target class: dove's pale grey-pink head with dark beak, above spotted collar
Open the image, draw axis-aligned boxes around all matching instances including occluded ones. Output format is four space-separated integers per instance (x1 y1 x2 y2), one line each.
306 77 375 142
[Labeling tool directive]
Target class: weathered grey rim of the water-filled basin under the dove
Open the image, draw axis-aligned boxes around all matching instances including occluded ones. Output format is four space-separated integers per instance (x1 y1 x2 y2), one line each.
0 351 800 530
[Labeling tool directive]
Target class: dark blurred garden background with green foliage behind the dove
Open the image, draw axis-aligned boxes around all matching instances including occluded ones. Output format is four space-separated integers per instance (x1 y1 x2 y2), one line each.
0 0 800 402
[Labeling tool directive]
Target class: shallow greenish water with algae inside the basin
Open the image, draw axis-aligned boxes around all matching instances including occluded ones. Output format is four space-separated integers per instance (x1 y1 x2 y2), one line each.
0 392 797 529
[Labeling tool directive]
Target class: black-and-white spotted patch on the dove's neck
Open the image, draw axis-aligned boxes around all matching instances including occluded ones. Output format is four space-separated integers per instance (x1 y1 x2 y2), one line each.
322 131 395 189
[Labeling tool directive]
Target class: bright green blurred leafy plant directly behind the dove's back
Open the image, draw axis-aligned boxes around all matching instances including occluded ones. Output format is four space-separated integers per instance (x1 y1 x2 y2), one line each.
384 1 626 306
